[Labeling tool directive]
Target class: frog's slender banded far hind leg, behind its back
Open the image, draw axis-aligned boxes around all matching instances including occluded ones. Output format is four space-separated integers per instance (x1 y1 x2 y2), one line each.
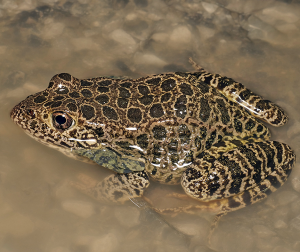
190 59 288 126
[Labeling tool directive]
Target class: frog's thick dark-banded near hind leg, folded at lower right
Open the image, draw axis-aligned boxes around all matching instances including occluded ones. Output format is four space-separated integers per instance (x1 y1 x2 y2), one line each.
181 141 295 211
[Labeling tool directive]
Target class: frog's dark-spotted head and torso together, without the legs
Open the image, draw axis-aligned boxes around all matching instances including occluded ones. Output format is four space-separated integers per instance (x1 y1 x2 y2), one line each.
12 70 268 184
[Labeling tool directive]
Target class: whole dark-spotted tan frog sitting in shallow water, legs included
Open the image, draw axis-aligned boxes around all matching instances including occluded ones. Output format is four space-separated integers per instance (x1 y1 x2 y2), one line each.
10 59 296 226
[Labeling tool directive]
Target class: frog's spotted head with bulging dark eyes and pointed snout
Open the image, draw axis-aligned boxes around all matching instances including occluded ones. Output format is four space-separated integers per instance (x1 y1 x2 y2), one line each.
10 73 104 155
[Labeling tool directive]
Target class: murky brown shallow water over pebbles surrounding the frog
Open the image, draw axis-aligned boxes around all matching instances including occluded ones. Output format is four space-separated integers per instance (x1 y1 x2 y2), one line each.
0 0 300 252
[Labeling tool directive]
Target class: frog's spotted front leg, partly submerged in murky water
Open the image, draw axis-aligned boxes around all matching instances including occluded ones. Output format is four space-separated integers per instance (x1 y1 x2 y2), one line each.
71 171 150 203
